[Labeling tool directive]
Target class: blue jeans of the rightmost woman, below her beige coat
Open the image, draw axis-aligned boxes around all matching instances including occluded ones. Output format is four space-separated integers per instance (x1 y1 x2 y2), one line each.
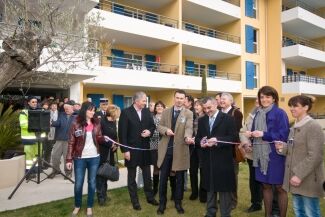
292 194 321 217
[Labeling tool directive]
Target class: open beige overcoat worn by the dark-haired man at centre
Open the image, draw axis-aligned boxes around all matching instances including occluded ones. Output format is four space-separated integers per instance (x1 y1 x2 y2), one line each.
157 107 193 171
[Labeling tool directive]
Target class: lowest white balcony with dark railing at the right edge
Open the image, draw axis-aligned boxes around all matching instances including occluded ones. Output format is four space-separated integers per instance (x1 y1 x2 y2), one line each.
282 75 325 96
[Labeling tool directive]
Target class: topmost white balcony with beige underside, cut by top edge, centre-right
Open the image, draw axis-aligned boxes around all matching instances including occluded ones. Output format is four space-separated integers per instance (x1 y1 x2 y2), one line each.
183 0 241 26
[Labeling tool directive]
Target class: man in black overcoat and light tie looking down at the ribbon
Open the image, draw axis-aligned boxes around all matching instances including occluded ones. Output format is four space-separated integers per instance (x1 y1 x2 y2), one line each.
195 97 236 217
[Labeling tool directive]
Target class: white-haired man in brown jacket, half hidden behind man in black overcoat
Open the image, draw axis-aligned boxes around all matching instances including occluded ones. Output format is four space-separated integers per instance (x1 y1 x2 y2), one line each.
220 93 243 209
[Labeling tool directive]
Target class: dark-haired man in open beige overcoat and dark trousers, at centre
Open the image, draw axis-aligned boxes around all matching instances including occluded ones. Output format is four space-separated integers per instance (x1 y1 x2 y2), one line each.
157 90 194 215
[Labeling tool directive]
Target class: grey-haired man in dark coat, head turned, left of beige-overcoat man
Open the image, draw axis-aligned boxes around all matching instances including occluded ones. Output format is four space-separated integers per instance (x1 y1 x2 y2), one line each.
118 92 158 210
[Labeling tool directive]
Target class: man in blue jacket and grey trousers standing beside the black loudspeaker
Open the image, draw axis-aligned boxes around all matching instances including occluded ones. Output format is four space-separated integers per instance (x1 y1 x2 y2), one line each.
48 101 75 179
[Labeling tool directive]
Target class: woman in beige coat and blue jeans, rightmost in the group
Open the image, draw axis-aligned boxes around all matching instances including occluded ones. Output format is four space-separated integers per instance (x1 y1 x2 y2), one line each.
275 95 324 217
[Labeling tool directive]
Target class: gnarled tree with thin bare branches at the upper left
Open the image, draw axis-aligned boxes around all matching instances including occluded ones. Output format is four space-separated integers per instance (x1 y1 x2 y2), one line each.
0 0 100 93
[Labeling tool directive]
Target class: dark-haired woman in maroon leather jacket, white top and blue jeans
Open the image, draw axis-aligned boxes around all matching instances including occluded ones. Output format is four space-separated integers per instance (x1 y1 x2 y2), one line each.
66 102 105 217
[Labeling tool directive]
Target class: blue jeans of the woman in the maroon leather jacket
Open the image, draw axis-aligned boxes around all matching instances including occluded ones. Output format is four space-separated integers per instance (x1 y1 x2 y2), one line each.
74 156 99 208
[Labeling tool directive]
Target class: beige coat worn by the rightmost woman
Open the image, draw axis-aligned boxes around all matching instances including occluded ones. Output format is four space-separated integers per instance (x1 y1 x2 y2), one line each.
280 119 325 197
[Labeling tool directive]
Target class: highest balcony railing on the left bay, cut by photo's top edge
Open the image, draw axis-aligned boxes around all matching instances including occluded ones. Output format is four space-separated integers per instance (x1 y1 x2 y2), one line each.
96 1 178 28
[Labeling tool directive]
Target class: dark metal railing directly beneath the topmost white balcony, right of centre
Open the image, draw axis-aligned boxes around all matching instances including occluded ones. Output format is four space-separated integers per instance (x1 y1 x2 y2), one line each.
182 22 240 44
